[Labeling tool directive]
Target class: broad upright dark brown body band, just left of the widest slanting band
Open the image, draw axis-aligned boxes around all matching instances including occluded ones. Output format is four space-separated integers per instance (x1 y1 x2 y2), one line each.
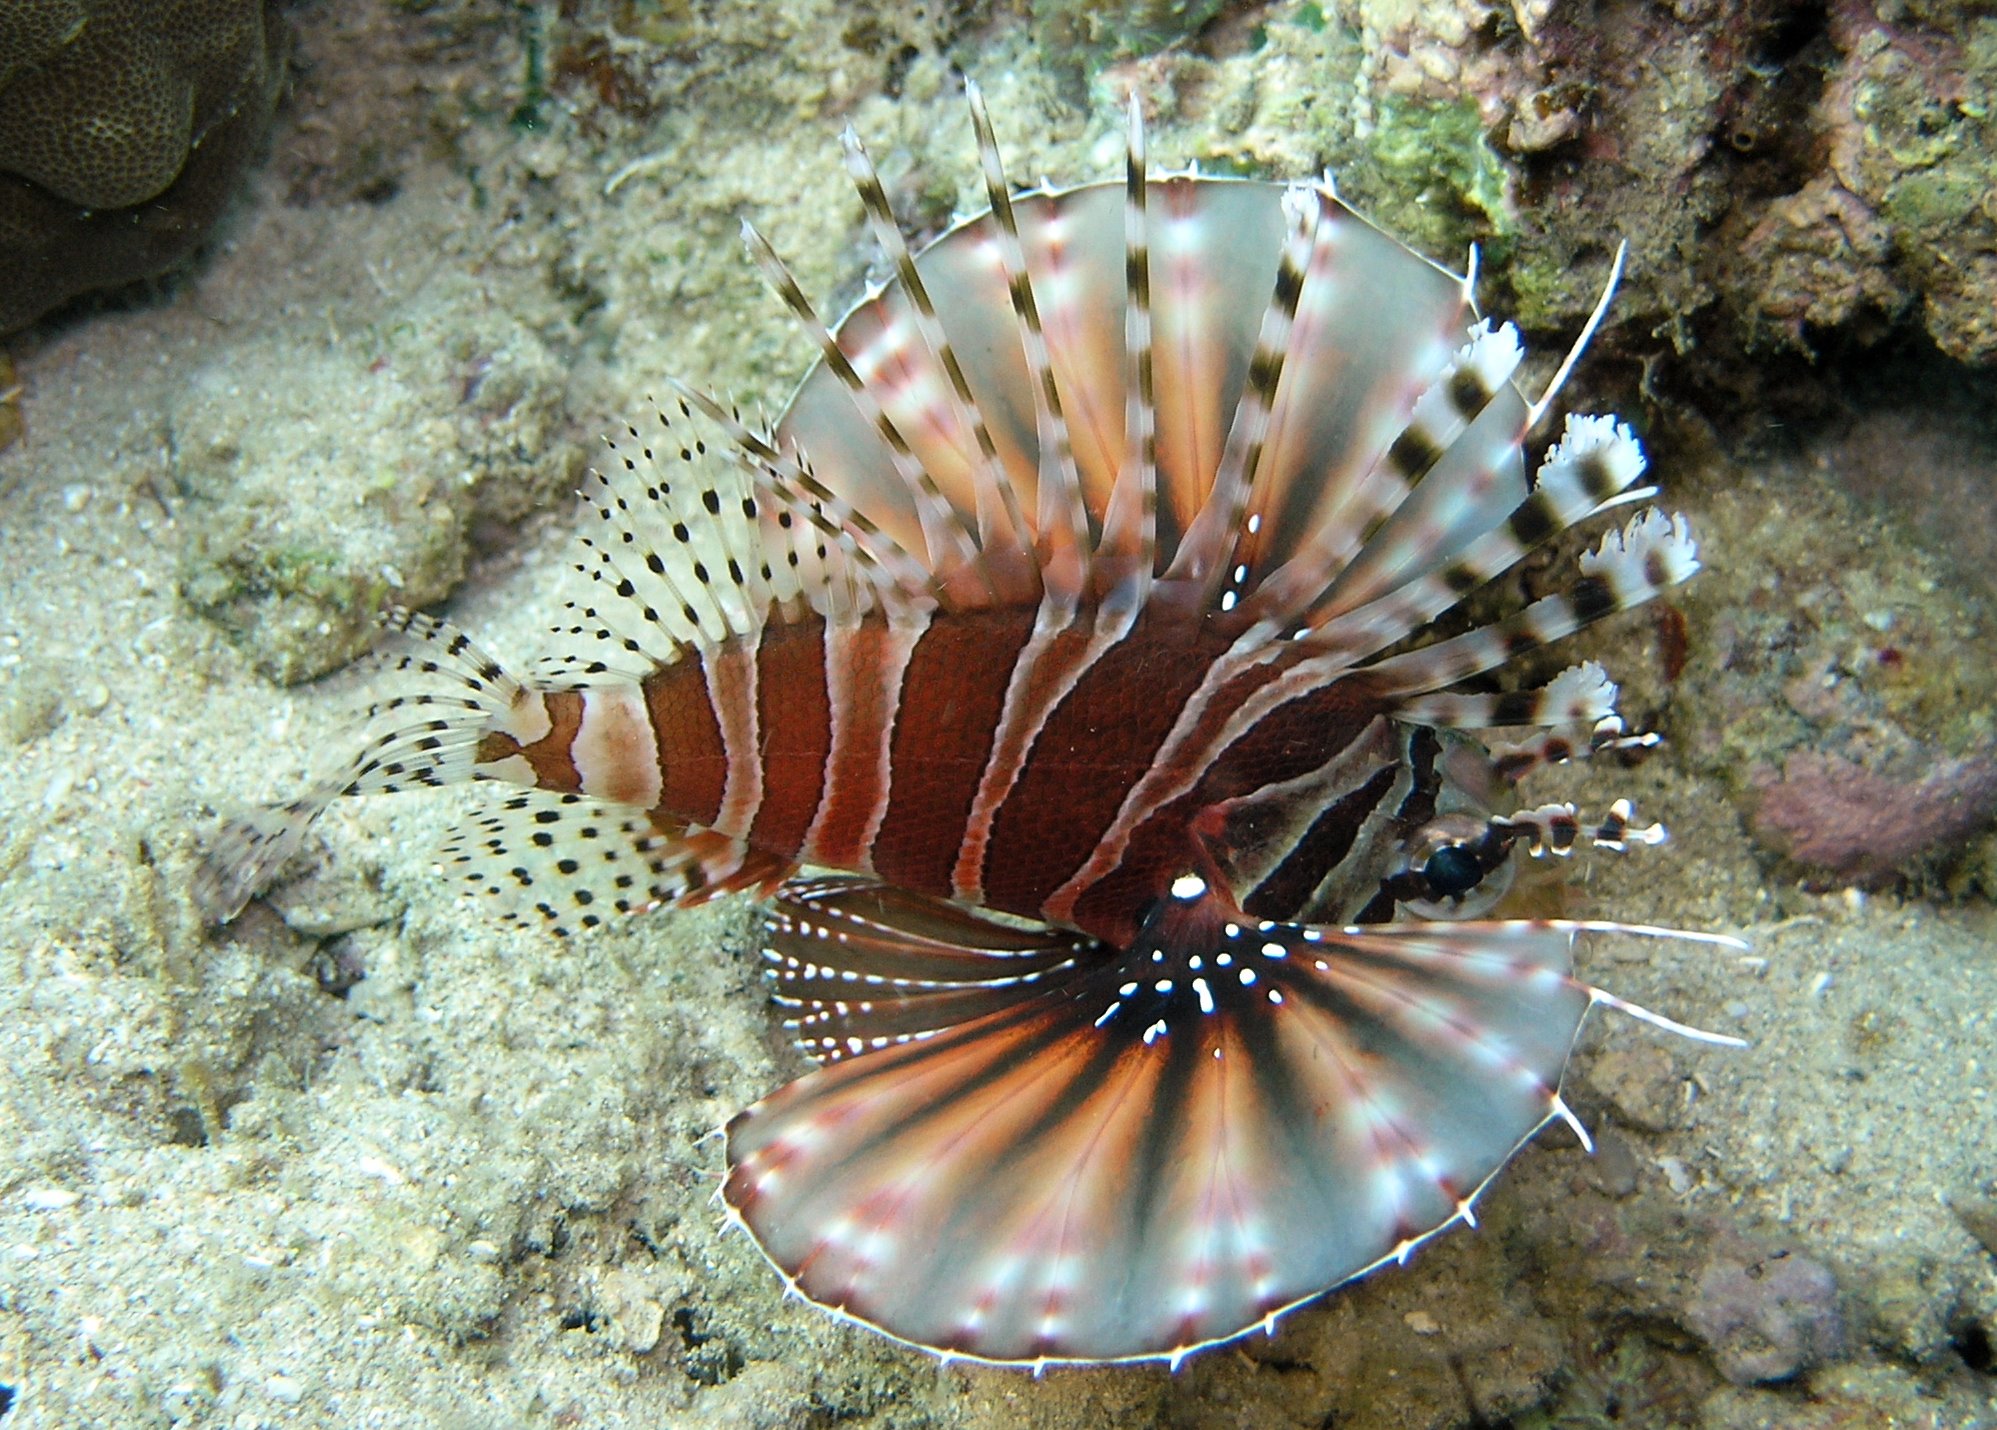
873 609 1032 897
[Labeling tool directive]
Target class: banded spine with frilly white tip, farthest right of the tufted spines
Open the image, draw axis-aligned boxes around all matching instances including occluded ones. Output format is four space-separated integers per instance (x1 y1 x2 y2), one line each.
1366 509 1699 703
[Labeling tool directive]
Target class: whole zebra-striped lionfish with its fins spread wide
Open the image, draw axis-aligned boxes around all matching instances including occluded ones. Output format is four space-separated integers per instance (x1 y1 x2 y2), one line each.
202 86 1733 1368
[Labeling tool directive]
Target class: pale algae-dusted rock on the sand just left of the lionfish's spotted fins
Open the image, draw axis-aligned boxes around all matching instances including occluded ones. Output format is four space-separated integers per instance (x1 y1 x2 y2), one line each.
172 315 581 683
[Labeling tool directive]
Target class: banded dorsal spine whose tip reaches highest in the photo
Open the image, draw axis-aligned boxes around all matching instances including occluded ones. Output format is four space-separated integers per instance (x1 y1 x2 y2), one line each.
965 80 1092 609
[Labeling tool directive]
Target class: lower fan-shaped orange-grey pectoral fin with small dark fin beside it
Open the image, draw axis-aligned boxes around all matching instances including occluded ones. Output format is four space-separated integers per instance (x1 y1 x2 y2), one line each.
723 877 1741 1364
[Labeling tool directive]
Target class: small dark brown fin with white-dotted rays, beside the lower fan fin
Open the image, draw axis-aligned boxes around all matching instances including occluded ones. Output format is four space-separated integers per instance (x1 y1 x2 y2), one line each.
763 879 1094 1063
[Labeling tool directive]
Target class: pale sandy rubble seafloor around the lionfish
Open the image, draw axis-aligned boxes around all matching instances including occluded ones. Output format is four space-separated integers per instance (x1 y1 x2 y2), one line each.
0 2 1997 1430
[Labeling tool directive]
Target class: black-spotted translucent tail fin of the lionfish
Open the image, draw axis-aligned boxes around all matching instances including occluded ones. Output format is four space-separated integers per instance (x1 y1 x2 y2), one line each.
194 609 523 923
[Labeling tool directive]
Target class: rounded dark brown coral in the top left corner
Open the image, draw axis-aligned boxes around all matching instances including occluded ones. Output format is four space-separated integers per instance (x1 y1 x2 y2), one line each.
0 0 278 332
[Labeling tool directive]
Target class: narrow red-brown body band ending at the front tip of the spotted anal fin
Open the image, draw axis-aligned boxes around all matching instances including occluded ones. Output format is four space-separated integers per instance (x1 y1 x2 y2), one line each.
749 617 833 855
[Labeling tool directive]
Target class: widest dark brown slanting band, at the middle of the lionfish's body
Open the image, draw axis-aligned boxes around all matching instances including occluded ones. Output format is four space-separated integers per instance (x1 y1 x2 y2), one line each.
985 607 1222 911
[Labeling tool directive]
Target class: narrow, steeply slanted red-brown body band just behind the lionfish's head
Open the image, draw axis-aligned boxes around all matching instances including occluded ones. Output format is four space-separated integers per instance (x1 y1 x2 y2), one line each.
1066 683 1380 943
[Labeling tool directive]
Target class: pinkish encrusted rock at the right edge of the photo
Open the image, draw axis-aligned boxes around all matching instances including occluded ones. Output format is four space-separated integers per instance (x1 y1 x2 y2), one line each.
1749 753 1997 883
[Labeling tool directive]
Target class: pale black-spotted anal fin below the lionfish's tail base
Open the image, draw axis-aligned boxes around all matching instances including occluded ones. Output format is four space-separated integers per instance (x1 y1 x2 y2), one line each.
437 789 793 937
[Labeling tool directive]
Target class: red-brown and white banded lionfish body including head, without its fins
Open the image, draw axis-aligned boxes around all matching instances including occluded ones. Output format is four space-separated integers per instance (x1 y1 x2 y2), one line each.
477 609 1440 943
